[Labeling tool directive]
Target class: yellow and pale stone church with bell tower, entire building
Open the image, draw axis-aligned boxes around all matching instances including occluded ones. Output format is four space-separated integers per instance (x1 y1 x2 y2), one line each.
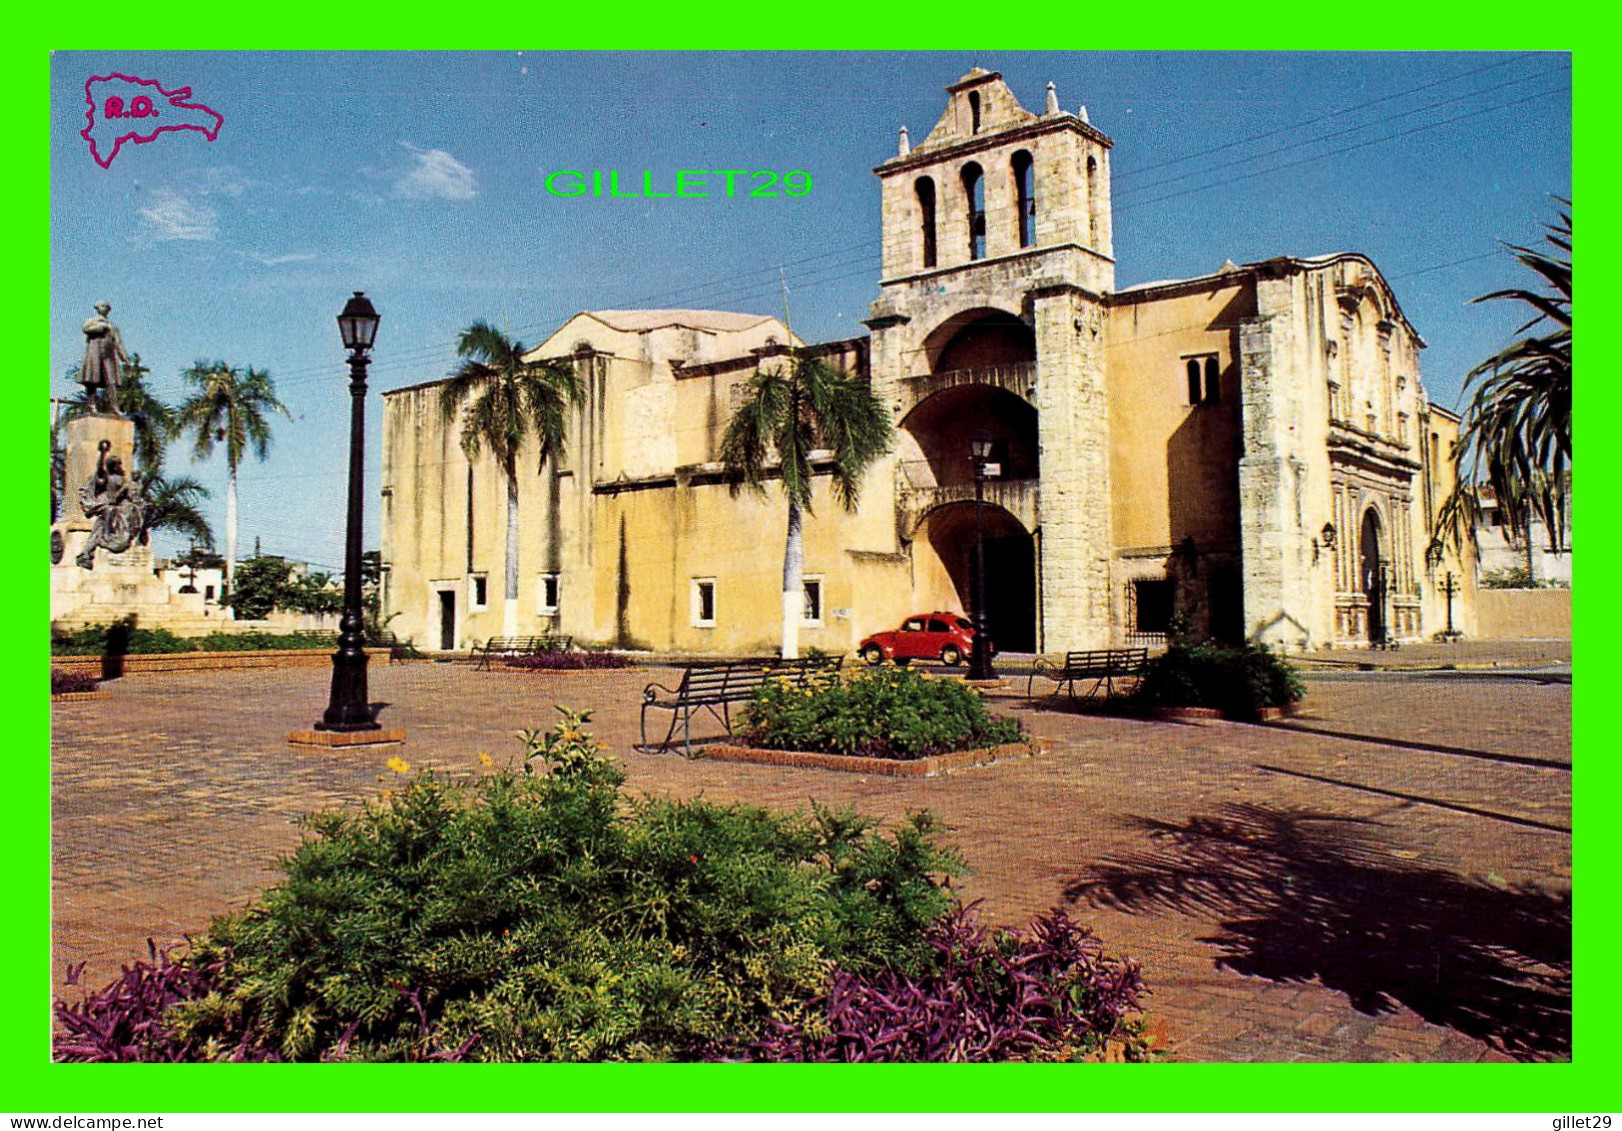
383 68 1474 654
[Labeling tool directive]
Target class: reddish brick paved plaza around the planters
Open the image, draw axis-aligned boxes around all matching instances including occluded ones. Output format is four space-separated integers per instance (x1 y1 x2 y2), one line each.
52 652 1572 1061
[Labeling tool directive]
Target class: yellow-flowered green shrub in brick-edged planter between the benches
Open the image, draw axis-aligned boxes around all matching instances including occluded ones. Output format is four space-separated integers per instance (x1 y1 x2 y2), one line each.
741 665 1022 759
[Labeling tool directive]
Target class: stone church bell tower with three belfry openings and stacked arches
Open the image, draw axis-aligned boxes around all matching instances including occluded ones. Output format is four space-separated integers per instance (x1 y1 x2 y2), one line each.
866 67 1114 651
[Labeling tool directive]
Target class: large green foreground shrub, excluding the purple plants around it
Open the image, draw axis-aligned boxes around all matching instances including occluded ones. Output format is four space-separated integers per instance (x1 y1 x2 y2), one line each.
165 711 960 1061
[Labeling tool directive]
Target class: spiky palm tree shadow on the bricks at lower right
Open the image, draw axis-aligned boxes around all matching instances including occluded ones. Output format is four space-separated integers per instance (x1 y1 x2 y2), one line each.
1066 805 1572 1060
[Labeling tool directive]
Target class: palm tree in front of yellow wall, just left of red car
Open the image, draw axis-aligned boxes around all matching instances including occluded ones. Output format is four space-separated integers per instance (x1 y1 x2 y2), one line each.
720 354 892 659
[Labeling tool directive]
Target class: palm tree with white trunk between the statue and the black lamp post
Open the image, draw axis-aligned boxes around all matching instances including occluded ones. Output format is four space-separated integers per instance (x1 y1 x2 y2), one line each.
174 362 292 591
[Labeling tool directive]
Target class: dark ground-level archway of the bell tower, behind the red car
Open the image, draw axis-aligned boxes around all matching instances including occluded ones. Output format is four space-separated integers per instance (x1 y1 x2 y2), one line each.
913 503 1036 652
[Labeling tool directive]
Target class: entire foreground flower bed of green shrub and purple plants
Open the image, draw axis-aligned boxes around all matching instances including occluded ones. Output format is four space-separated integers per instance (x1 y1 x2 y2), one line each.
55 711 1150 1061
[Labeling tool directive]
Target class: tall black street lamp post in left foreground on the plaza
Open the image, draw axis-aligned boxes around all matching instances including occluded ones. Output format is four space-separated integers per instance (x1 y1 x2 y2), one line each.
315 290 381 732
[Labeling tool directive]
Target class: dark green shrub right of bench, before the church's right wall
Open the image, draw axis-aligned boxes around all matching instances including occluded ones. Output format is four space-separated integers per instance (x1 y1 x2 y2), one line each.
1134 644 1306 719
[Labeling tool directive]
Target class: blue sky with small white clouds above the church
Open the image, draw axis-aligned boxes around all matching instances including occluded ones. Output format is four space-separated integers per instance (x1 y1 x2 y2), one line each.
50 50 1572 565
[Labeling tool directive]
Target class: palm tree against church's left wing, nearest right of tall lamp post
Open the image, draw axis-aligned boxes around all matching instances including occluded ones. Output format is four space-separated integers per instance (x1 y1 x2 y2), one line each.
440 321 581 636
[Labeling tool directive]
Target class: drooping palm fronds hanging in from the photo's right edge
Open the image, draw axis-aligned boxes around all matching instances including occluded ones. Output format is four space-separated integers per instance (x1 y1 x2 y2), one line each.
1439 200 1572 560
